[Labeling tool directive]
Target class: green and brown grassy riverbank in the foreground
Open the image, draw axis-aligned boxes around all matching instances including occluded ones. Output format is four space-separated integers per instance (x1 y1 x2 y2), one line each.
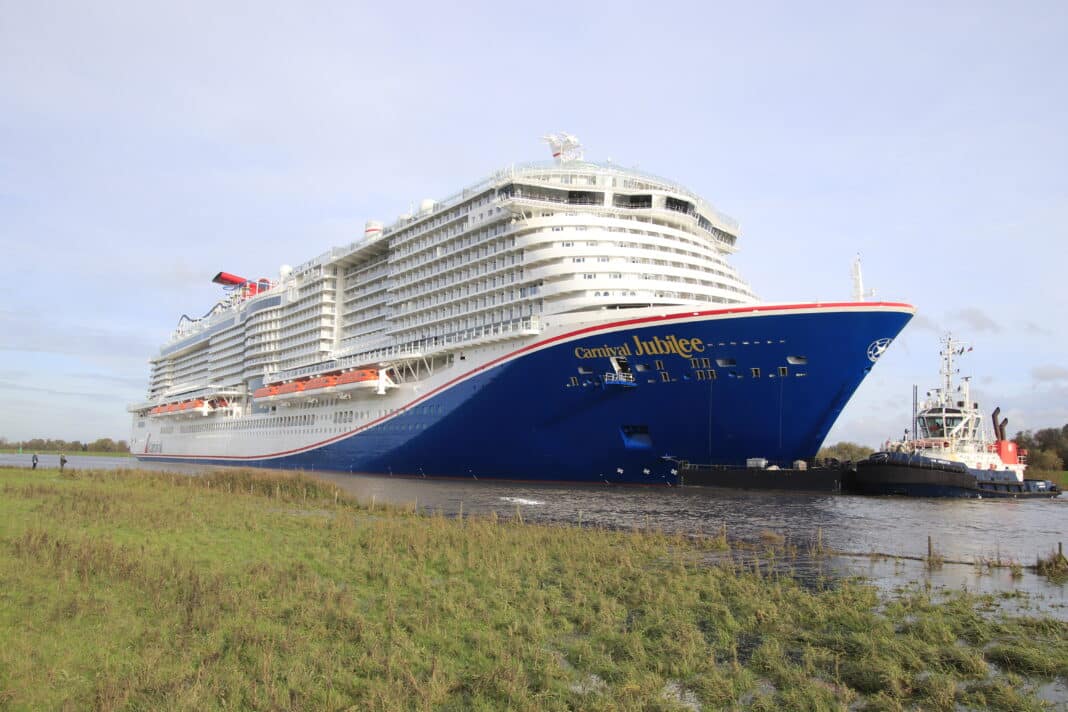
0 470 1068 710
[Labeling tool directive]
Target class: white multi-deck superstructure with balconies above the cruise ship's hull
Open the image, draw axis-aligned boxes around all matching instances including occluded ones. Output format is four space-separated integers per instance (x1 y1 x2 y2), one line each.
130 135 755 431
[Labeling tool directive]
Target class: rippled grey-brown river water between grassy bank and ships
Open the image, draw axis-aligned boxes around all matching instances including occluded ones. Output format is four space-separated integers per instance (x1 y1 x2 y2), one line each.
0 455 1068 618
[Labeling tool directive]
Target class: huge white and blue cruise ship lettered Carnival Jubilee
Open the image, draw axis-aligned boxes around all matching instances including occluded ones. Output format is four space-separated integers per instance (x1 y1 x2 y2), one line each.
122 133 914 485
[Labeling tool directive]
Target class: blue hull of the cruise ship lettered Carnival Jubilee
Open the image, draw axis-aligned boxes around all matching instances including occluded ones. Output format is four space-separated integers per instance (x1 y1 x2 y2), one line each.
139 303 913 485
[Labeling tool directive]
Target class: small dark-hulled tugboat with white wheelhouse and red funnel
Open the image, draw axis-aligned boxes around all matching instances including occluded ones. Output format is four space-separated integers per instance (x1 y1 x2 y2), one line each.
852 335 1061 499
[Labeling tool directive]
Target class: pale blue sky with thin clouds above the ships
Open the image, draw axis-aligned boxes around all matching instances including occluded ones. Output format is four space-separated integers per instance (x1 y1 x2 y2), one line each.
0 0 1068 446
